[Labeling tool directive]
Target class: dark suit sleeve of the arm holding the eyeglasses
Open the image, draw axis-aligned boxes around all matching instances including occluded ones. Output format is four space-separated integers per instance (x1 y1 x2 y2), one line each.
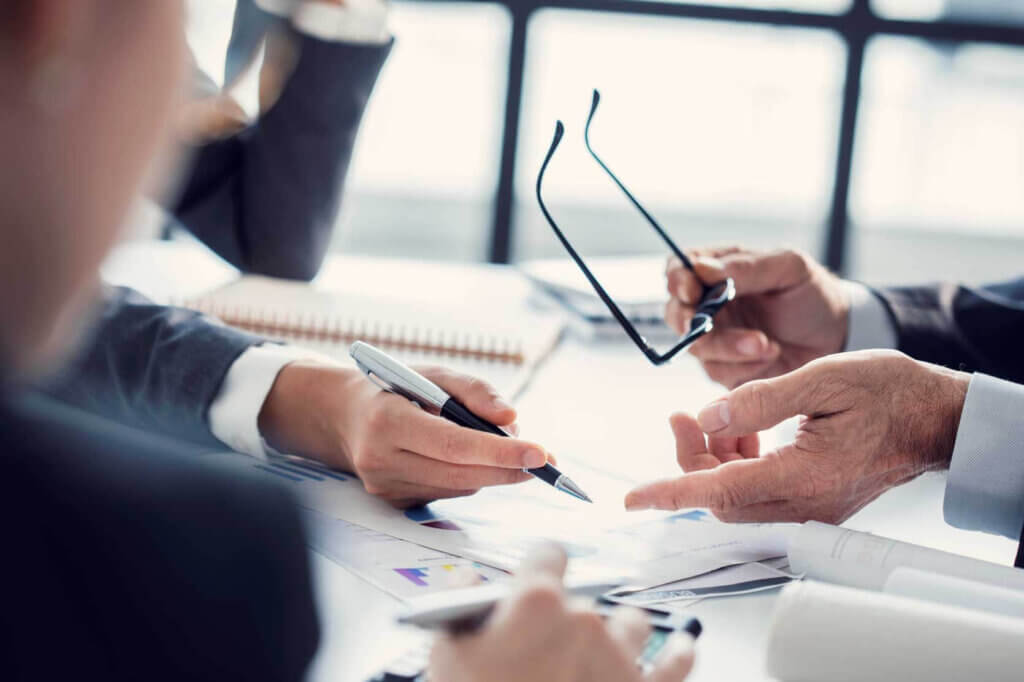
876 279 1024 383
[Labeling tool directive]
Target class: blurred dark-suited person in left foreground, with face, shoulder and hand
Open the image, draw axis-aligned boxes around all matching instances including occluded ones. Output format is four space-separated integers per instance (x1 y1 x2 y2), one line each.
0 0 691 682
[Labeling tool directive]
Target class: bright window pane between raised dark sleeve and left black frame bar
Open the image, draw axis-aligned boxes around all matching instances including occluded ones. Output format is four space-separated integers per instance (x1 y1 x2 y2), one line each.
335 3 511 260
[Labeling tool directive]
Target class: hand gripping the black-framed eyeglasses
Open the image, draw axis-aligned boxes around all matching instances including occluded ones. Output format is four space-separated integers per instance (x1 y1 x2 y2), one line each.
665 247 850 388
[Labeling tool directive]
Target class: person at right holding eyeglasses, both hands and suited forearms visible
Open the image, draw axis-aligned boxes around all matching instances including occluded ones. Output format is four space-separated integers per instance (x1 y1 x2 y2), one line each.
626 247 1024 565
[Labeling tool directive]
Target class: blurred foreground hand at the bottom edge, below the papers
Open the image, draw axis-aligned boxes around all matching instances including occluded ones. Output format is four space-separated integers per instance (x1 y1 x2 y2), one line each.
430 549 693 682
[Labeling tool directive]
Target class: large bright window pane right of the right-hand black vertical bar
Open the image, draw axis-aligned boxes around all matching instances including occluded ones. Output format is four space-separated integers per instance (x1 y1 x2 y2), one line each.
851 38 1024 282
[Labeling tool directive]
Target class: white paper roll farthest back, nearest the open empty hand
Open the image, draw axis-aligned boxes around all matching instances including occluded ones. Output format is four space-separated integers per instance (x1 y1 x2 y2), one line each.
788 521 1024 590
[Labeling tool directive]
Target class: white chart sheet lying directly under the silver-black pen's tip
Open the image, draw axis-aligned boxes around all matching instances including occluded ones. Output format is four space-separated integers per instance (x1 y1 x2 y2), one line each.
234 448 785 590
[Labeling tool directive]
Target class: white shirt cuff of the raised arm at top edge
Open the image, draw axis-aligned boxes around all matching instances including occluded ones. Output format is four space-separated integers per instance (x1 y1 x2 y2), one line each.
255 0 389 44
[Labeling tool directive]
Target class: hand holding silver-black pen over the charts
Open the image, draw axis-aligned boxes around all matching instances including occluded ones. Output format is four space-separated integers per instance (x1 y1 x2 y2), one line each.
259 361 548 507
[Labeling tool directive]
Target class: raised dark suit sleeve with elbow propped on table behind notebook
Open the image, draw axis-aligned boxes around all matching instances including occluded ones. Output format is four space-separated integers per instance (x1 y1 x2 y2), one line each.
171 36 391 280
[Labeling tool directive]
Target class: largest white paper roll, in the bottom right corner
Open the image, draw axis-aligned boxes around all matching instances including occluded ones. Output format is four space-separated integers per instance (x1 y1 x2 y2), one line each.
767 581 1024 682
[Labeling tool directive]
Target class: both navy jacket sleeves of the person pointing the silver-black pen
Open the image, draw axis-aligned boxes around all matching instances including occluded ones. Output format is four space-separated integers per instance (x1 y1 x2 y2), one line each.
45 25 390 444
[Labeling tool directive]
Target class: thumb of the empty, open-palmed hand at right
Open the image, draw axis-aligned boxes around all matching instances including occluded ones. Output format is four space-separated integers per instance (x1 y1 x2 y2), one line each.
697 367 822 436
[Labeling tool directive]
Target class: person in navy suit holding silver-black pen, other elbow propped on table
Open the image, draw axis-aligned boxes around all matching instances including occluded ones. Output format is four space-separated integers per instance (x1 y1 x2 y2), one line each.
45 0 548 506
